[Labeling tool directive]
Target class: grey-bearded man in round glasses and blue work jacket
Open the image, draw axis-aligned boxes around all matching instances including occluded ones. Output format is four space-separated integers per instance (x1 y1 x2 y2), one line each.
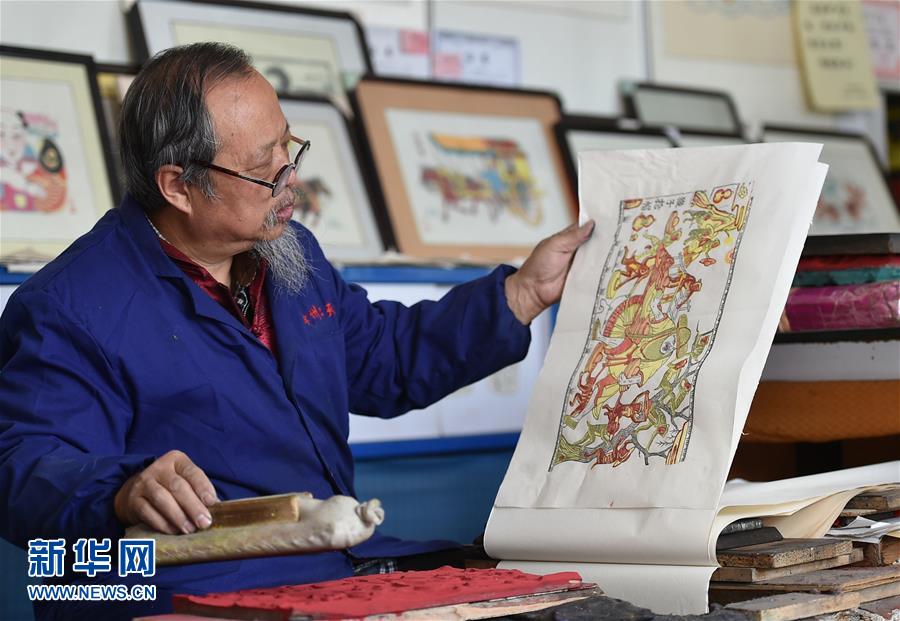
0 44 591 619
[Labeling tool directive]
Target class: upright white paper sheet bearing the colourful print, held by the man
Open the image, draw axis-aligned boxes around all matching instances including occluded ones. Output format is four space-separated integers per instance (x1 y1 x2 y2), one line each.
496 144 824 509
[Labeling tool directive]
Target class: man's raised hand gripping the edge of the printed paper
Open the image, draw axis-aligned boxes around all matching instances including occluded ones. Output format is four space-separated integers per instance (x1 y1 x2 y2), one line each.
505 220 594 325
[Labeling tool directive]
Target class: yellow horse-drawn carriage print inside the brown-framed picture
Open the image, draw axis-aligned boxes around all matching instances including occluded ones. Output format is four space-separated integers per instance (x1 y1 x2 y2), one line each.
421 134 543 226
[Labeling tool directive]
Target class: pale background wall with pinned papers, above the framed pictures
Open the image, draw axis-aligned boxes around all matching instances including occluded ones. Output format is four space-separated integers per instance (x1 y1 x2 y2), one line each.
0 0 884 153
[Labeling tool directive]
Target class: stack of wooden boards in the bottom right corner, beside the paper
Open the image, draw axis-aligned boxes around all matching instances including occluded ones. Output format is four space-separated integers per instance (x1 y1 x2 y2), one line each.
709 485 900 621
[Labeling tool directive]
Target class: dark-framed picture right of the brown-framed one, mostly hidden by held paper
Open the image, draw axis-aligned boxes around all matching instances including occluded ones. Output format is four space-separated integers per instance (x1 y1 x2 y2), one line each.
556 115 674 193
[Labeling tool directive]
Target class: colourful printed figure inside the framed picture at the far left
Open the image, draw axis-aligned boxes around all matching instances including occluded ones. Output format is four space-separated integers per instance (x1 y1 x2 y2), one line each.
0 108 66 213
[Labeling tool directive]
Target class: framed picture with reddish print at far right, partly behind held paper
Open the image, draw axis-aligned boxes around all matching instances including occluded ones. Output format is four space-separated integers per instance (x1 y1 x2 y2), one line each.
763 125 900 235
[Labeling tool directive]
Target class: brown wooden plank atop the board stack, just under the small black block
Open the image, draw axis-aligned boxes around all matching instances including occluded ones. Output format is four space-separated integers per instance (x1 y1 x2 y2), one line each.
716 539 853 568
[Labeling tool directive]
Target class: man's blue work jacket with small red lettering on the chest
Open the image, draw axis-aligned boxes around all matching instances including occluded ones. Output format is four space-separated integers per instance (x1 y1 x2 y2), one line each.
0 197 530 619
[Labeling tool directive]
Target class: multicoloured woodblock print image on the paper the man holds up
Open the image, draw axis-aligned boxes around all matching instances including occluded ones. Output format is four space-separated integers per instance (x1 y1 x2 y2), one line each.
550 182 753 469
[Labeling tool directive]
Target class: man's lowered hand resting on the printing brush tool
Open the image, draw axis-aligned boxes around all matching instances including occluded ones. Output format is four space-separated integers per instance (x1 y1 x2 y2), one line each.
114 451 217 535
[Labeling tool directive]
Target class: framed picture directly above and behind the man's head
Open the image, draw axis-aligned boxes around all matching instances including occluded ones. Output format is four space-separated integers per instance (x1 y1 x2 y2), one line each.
129 0 372 110
